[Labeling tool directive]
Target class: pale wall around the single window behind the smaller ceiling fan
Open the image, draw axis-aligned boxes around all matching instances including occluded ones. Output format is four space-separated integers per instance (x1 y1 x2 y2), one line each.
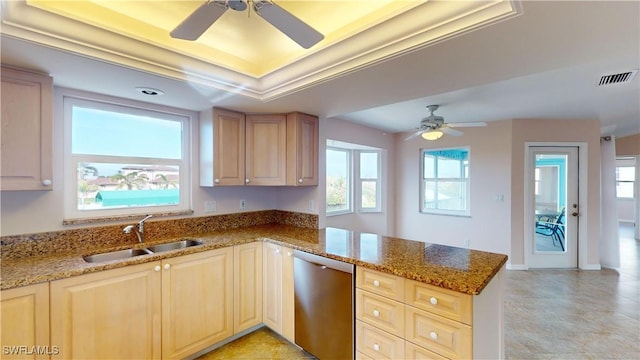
395 121 511 254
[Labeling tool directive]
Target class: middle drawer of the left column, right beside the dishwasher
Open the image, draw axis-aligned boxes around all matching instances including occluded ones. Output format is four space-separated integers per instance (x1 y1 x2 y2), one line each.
356 289 404 336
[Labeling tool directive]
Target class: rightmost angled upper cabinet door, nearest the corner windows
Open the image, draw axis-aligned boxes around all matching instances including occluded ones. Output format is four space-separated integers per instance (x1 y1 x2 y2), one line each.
287 112 318 186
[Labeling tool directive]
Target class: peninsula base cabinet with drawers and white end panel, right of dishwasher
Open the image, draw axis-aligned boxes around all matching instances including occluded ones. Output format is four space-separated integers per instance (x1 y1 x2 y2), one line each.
356 267 504 359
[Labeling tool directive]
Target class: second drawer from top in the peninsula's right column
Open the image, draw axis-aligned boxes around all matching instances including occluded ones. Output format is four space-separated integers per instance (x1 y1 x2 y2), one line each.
405 306 472 359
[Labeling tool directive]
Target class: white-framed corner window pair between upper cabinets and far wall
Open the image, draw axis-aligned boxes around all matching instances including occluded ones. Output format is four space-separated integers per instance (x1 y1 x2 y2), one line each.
326 140 382 215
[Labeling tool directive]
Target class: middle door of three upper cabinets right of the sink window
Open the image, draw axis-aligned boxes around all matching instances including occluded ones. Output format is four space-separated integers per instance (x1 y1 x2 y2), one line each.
245 114 287 185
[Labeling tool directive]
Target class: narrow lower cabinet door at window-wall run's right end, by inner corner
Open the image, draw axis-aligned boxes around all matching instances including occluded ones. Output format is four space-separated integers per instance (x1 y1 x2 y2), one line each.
233 242 262 334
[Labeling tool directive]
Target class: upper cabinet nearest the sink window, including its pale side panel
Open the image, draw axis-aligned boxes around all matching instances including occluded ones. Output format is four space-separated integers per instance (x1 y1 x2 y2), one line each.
200 108 245 186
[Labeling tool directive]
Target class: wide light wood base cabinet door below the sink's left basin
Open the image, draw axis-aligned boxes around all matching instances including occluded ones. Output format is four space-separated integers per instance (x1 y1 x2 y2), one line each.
51 262 162 359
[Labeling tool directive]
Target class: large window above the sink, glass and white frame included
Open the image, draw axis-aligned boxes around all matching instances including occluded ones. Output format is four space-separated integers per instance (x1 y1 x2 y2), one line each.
63 96 191 218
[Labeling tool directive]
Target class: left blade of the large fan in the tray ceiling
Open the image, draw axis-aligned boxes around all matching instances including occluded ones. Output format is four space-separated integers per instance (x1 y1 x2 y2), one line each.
169 0 228 40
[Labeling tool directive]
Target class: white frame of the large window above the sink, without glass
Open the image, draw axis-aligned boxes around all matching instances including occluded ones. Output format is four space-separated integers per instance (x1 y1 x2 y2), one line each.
61 91 194 221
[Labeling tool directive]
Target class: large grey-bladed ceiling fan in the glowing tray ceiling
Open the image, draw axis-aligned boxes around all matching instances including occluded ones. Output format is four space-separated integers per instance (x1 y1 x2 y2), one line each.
170 0 324 49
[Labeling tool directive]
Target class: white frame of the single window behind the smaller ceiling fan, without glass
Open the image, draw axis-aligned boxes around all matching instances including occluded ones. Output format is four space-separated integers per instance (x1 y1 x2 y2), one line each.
418 146 471 217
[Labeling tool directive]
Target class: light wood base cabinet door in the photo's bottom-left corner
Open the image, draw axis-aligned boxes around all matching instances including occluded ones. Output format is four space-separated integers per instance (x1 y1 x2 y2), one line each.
0 283 50 359
